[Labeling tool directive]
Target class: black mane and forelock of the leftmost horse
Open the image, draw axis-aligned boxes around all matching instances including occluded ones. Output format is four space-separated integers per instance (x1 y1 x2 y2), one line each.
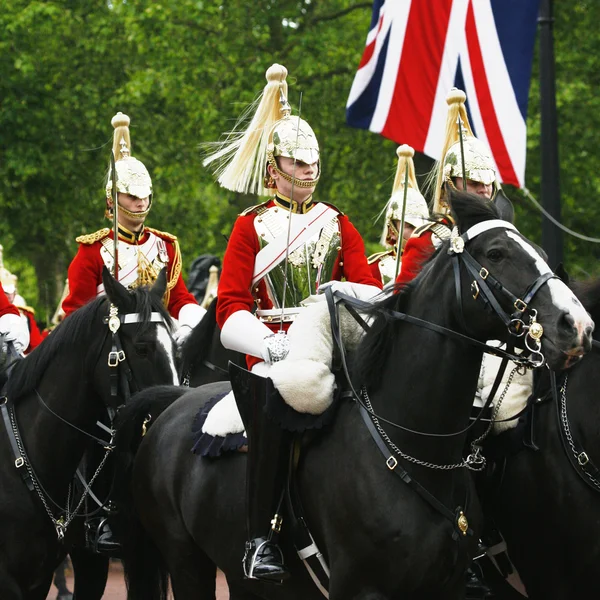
7 288 172 402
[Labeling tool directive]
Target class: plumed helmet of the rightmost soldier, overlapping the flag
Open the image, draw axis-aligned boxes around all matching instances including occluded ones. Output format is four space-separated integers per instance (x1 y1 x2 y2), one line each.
433 88 500 213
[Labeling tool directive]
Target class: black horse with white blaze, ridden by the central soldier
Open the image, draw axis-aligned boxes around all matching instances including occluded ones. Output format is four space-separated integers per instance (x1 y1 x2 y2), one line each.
116 193 592 600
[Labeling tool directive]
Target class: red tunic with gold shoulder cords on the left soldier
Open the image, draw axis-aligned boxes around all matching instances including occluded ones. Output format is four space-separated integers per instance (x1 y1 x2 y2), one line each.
62 229 198 318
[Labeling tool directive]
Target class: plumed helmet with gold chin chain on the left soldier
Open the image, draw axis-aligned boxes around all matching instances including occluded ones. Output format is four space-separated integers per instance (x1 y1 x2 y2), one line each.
106 112 152 219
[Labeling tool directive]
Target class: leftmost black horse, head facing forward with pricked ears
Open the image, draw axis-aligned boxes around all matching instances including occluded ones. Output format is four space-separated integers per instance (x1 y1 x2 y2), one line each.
0 270 177 600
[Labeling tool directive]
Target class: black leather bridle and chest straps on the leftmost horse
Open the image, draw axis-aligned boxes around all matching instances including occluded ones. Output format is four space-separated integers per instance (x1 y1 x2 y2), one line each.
0 303 165 541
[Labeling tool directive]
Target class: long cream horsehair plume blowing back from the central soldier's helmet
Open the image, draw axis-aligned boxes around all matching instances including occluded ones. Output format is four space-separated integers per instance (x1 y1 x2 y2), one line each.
202 63 288 195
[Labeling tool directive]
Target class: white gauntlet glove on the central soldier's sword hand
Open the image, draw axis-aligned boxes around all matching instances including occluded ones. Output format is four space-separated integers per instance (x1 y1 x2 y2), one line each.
221 310 289 364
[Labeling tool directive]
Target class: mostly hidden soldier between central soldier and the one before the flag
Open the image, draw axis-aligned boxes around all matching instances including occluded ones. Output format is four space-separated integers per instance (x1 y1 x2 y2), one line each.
368 145 429 285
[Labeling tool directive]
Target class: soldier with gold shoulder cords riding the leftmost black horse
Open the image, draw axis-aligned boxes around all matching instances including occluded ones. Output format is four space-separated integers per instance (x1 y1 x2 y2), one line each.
62 113 206 345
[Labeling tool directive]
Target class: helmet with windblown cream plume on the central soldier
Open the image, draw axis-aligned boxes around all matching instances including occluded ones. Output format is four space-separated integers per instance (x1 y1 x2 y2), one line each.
203 64 319 196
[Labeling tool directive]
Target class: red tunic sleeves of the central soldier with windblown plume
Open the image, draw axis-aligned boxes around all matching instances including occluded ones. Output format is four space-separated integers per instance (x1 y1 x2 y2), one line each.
217 201 381 368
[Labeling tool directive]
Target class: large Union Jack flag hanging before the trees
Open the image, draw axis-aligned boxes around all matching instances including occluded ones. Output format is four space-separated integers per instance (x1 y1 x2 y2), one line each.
346 0 539 187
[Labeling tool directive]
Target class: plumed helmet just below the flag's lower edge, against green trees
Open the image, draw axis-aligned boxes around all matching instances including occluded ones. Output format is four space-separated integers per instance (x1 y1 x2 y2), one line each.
379 144 429 248
